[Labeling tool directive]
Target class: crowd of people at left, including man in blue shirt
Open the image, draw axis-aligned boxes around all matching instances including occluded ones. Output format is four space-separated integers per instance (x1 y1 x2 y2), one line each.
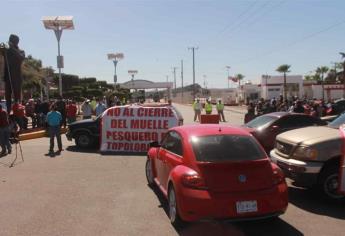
0 96 126 157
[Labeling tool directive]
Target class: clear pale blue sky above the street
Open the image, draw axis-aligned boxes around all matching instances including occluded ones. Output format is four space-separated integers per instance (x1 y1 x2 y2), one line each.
0 0 345 88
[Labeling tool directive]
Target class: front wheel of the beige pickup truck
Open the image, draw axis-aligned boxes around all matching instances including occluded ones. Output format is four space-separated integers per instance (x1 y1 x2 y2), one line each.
319 166 344 201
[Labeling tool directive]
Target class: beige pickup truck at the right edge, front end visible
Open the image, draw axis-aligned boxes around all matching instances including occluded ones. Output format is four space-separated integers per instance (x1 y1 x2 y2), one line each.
270 113 345 200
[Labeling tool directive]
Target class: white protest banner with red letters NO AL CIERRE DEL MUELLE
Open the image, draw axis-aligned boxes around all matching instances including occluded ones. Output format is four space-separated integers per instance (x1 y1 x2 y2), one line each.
100 105 179 153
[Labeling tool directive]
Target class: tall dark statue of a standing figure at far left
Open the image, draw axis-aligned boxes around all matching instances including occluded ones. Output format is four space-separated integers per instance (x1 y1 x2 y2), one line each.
2 34 25 114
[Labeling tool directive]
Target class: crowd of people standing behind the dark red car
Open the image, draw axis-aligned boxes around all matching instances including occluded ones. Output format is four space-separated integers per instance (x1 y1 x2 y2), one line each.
245 95 332 123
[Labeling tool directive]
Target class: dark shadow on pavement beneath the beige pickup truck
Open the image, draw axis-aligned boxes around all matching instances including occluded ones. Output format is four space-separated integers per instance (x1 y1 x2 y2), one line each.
289 187 345 219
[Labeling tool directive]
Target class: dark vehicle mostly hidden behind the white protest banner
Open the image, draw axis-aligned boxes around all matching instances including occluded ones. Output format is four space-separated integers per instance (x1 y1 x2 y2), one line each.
66 104 183 148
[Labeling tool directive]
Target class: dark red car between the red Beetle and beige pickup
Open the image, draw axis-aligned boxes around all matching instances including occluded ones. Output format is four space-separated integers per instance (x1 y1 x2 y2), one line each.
243 112 327 153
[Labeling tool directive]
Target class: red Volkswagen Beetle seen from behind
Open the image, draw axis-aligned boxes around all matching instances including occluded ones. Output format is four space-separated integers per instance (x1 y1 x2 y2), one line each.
146 125 288 225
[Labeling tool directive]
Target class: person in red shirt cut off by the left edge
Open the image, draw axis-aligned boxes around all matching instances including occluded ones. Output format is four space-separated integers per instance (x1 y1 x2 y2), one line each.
0 104 12 156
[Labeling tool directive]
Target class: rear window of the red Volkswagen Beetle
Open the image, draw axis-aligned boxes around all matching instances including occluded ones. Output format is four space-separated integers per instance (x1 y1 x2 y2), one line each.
191 135 265 162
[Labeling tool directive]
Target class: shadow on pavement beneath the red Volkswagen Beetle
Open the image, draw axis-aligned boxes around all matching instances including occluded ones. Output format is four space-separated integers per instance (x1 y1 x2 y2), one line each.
148 186 303 236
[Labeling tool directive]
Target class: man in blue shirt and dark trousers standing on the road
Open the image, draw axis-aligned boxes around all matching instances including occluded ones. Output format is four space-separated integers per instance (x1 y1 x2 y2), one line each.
47 104 63 156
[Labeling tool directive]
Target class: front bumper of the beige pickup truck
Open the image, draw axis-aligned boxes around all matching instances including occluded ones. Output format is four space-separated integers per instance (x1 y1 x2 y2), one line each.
270 150 323 187
